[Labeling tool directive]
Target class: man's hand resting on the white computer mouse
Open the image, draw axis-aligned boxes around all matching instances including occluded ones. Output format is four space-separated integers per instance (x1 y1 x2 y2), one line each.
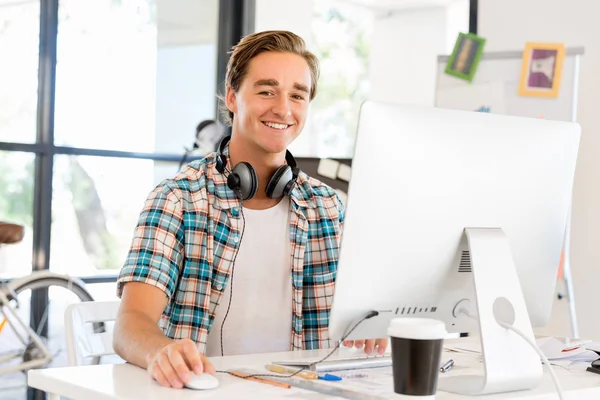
146 339 215 389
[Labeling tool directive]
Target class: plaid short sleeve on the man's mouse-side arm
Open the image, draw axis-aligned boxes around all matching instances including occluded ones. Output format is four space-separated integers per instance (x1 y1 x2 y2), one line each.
117 185 184 298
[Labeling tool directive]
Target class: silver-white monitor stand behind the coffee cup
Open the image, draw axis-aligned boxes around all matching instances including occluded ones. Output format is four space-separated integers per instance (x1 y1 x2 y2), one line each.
438 228 543 395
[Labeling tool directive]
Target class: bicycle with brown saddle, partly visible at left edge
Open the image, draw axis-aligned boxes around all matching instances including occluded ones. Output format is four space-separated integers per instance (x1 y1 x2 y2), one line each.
0 222 104 375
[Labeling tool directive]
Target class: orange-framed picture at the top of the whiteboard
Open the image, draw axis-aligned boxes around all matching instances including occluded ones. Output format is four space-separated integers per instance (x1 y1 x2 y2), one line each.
519 43 565 98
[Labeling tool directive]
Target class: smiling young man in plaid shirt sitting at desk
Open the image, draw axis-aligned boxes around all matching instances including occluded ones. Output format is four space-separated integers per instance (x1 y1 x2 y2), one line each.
114 31 387 388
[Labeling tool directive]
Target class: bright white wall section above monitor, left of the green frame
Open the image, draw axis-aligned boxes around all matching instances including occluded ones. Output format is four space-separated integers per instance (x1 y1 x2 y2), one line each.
371 0 469 106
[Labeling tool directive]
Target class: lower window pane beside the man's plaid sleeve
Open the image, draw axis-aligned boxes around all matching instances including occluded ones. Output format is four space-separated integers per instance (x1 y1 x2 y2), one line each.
50 155 177 276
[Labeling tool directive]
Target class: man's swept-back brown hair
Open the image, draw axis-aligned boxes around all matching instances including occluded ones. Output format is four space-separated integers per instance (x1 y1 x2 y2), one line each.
221 31 319 125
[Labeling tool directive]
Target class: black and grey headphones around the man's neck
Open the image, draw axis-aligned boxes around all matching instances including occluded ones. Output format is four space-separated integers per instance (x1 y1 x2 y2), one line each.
217 135 300 201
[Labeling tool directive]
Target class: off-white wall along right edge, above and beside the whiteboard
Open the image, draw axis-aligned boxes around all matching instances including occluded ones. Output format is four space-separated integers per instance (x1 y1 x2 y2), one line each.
479 0 600 339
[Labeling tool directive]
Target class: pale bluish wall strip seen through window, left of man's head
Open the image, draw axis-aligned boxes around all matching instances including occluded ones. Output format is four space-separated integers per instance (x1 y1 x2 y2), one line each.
154 0 219 183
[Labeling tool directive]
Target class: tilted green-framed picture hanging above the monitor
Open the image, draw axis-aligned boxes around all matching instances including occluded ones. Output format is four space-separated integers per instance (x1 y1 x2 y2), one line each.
446 33 485 82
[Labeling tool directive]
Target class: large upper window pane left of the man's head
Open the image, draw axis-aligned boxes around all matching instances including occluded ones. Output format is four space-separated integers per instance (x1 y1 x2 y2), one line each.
55 0 218 154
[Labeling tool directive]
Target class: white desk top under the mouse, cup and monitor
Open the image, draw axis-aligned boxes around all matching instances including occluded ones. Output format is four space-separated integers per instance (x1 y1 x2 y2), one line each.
28 349 600 400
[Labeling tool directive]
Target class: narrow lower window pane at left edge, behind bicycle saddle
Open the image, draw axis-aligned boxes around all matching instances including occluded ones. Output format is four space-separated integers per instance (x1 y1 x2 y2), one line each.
0 151 35 278
